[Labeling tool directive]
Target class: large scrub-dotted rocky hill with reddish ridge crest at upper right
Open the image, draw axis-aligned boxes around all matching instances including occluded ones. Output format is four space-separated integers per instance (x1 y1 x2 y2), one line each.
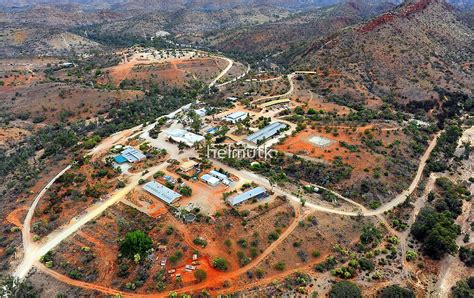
290 0 474 109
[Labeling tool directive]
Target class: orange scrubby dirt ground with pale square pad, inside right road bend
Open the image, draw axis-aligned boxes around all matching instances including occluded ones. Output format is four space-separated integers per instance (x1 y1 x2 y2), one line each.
275 124 429 207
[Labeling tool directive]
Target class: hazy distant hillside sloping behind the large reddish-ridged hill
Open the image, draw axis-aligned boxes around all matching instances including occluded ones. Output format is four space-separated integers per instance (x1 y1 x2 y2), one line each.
209 1 394 58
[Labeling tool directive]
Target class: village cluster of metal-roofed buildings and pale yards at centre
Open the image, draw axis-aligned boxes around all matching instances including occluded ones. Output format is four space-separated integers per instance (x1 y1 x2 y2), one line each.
109 97 290 215
